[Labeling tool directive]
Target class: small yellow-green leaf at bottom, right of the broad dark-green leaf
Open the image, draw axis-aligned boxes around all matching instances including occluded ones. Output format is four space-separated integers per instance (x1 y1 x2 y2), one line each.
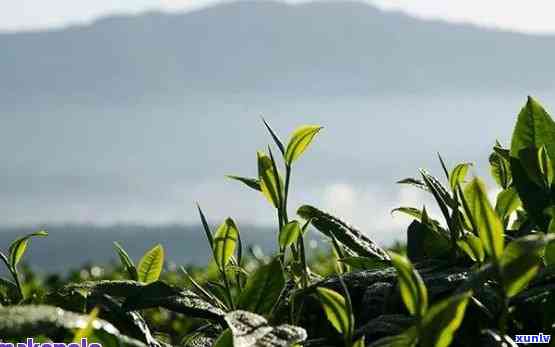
316 287 354 335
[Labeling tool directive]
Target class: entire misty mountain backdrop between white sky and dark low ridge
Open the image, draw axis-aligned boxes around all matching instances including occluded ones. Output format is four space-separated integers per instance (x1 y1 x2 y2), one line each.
0 1 555 241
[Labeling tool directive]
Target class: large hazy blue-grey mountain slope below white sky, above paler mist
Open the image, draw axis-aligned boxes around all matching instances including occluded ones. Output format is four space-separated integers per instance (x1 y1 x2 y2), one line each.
0 1 555 109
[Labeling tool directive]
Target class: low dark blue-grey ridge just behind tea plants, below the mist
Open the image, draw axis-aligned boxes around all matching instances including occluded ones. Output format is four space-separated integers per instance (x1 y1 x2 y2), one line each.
0 225 282 274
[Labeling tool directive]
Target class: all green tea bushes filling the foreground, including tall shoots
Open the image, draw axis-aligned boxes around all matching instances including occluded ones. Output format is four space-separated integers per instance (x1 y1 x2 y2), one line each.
0 98 555 347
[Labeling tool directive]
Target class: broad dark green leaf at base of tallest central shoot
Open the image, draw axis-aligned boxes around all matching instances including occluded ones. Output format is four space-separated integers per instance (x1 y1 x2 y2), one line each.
238 258 285 314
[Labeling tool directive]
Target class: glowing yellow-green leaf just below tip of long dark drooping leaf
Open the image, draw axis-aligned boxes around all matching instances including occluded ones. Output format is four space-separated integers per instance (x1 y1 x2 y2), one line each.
389 252 428 317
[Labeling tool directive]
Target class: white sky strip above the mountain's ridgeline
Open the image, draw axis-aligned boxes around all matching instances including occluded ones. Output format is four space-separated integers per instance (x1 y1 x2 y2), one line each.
0 0 555 33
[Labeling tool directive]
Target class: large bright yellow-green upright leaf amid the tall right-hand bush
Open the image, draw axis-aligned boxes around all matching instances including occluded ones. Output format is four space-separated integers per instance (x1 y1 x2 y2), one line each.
465 178 504 259
